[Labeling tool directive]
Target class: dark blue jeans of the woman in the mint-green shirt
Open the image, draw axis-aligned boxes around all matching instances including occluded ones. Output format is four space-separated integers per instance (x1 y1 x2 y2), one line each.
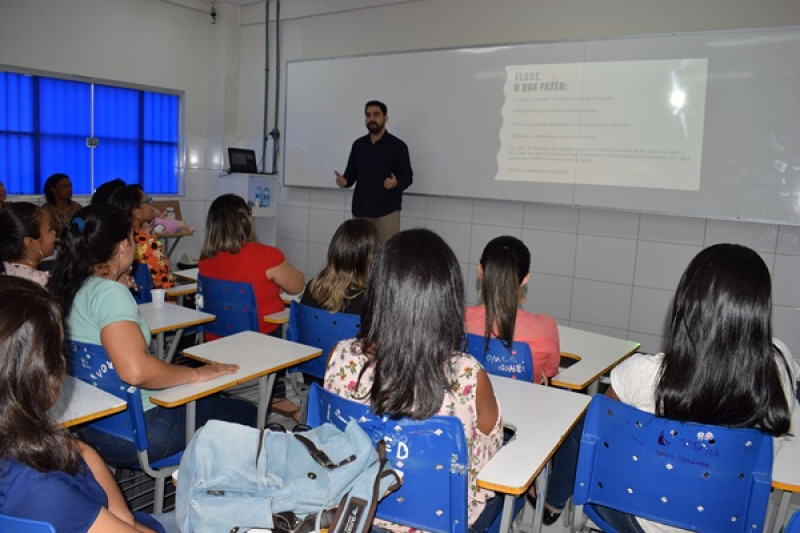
78 396 257 468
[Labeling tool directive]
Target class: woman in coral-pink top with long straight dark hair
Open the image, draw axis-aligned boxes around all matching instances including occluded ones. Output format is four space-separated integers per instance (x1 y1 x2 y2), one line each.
466 235 561 384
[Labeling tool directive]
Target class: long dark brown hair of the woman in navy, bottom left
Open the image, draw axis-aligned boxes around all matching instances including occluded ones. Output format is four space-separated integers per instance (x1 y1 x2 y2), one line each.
0 276 80 474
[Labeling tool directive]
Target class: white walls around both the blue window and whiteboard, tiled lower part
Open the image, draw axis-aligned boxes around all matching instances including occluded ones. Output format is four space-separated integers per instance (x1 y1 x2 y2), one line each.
0 0 800 355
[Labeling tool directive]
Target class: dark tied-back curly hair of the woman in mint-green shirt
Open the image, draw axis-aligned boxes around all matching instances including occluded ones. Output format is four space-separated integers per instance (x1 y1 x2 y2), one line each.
47 204 131 318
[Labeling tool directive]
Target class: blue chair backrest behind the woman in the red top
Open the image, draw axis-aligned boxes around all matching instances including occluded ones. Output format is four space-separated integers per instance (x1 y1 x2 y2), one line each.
197 275 261 337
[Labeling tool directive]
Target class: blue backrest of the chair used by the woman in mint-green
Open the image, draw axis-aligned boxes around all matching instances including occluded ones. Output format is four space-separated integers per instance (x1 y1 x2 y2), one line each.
65 340 147 451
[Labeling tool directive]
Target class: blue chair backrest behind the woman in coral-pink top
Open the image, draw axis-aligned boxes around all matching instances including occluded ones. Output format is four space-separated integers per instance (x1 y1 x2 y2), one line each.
465 333 533 381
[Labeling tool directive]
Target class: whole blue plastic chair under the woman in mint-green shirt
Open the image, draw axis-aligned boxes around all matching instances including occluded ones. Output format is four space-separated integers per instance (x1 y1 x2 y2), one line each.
65 340 183 513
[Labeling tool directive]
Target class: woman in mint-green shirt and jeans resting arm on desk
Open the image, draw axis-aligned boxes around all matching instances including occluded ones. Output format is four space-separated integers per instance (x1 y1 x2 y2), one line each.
48 204 256 467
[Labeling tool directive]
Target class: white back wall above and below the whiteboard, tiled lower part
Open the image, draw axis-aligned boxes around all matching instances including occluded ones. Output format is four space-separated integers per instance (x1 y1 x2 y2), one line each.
239 0 800 356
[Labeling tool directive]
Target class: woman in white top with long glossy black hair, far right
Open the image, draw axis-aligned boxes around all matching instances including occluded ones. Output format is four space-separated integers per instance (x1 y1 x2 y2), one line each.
598 244 798 533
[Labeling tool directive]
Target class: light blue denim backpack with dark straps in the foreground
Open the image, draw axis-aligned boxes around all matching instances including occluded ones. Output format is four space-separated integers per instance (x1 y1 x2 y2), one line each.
175 420 402 533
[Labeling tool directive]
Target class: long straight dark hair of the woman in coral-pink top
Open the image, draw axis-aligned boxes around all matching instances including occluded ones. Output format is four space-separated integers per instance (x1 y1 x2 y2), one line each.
480 235 531 347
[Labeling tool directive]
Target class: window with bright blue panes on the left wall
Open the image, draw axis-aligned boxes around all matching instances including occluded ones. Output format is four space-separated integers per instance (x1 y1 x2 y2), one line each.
0 72 180 195
